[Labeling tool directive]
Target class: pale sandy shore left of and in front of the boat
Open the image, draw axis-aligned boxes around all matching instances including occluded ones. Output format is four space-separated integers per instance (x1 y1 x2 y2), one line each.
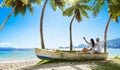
0 59 119 70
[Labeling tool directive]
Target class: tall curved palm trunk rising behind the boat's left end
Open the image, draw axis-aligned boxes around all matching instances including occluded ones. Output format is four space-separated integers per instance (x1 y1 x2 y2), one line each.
40 0 48 49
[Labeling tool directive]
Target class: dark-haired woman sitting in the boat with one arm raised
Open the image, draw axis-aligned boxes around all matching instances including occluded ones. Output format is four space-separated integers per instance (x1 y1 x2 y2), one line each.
82 37 95 53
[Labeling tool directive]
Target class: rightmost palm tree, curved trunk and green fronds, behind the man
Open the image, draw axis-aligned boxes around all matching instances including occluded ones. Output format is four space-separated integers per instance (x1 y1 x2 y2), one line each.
93 0 120 53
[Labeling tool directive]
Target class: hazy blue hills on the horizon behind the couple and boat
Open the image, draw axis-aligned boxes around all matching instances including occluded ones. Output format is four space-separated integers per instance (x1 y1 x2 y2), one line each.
59 38 120 49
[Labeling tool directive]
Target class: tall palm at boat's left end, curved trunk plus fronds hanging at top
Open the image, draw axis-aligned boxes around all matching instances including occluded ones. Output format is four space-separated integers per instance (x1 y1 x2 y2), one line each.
40 0 64 49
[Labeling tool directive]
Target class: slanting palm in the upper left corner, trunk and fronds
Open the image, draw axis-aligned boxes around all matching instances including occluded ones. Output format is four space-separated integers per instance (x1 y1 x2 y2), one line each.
0 0 41 30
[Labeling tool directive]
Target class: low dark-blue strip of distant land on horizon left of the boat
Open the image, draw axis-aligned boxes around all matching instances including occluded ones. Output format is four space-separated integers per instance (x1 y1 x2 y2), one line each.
0 47 33 51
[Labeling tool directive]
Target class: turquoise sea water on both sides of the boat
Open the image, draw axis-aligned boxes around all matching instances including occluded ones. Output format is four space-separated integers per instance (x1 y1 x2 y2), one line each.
0 49 120 61
